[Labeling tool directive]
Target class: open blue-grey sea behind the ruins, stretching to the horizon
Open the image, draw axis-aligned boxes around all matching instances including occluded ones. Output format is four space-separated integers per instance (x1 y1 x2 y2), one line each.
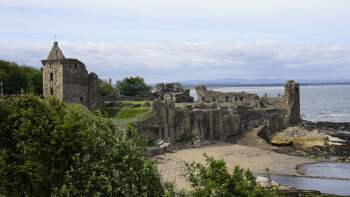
191 85 350 122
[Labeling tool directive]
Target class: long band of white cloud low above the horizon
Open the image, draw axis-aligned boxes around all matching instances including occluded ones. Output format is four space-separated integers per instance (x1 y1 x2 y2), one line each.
0 41 350 82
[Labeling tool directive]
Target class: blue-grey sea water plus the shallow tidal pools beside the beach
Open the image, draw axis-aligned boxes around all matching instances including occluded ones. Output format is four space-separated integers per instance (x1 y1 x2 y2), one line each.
191 85 350 196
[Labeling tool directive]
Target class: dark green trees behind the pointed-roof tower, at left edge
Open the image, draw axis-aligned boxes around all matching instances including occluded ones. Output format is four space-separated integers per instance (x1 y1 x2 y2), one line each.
0 60 43 95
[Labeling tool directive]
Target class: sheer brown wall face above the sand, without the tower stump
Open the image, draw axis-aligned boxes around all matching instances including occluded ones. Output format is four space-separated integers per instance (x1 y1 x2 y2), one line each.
137 102 287 144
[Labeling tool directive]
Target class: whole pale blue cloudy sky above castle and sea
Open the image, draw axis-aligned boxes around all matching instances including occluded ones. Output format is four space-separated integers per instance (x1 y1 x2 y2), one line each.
0 0 350 82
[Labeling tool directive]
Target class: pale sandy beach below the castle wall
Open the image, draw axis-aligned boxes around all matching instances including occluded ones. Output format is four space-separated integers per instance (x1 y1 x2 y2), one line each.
154 127 314 189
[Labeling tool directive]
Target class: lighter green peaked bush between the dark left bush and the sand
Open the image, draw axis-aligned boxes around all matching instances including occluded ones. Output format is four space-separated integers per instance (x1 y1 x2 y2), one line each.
57 111 163 196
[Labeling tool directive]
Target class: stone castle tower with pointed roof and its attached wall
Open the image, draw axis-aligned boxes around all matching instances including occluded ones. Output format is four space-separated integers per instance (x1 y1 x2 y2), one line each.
41 42 103 111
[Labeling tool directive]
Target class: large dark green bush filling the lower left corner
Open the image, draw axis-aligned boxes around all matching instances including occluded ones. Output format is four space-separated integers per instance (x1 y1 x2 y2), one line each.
0 95 86 196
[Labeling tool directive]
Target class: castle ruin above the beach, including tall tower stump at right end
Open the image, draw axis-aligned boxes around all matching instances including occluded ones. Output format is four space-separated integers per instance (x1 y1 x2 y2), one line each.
136 81 300 149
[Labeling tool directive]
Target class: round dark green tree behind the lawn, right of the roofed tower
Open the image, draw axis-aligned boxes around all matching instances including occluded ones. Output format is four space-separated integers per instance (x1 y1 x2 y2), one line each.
116 76 152 96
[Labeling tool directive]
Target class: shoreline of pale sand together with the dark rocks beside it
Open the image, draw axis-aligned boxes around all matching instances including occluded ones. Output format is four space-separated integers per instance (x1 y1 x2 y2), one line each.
151 121 350 196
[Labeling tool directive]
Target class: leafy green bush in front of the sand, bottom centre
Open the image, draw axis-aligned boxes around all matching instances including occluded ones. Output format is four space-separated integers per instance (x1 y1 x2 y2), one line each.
185 153 275 196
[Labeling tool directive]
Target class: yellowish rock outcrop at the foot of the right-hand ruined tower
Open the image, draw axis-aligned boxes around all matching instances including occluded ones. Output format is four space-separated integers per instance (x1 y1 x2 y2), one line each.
270 126 329 147
